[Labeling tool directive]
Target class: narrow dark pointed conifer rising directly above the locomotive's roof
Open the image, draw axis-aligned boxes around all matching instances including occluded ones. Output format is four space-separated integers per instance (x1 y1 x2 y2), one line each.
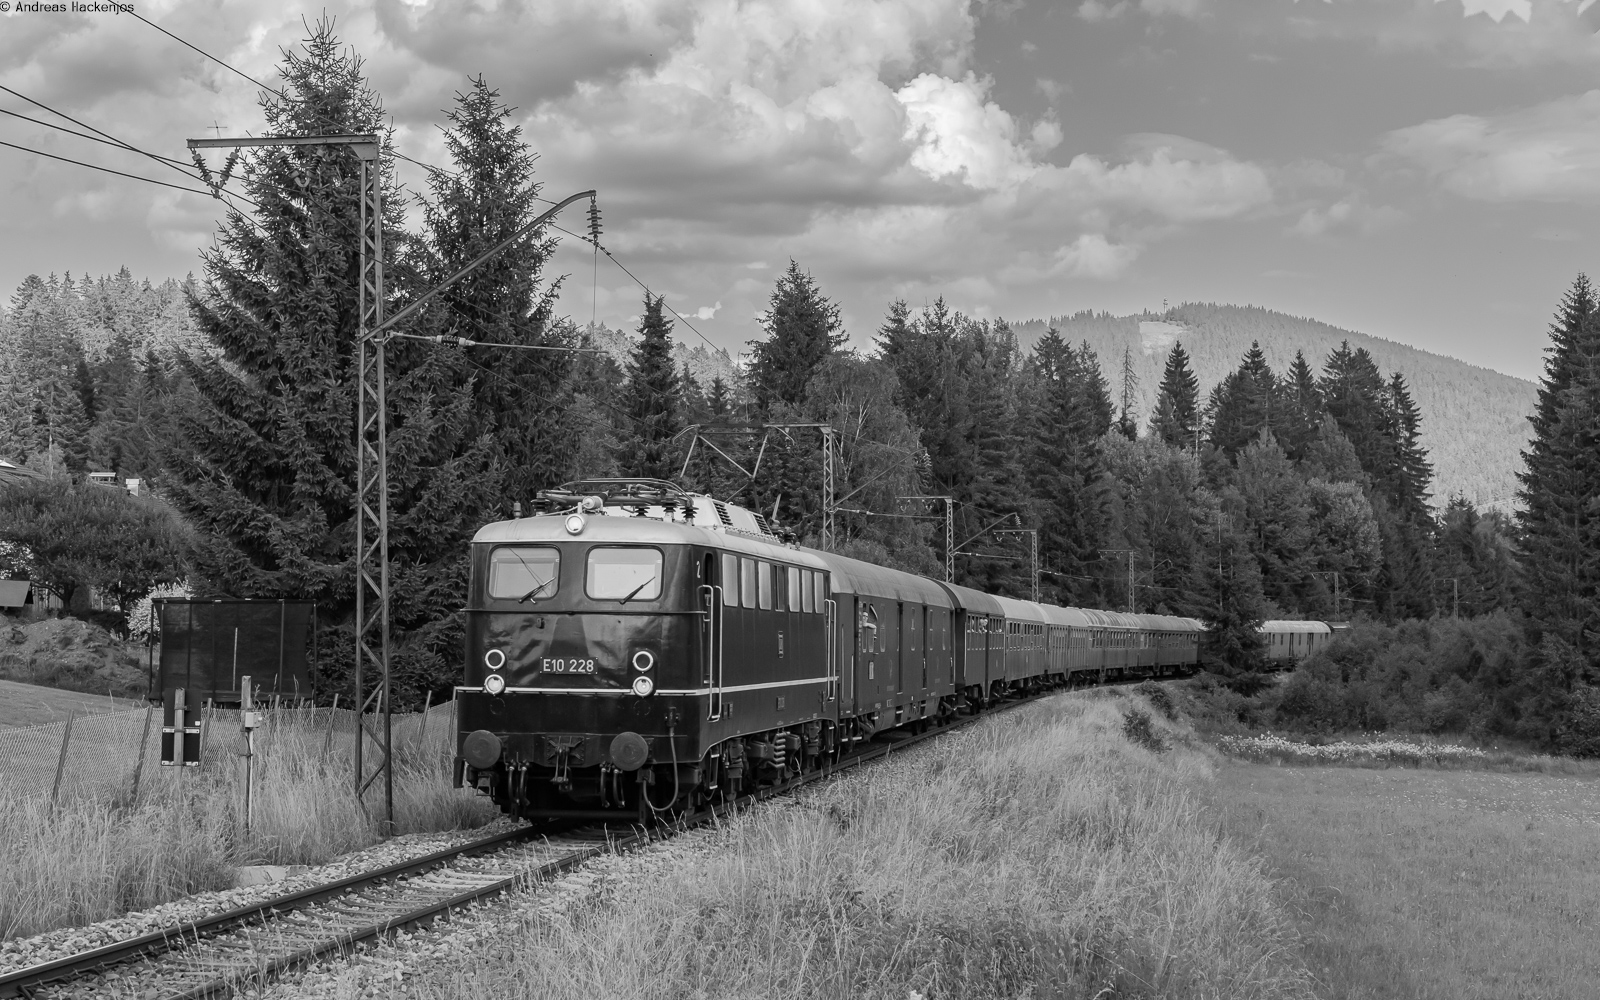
616 293 683 480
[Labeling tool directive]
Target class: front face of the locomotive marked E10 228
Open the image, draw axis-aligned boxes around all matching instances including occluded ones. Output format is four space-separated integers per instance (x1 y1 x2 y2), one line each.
456 512 707 819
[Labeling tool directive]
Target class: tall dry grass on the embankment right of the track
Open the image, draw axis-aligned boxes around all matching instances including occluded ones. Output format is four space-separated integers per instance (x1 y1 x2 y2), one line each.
410 696 1310 1000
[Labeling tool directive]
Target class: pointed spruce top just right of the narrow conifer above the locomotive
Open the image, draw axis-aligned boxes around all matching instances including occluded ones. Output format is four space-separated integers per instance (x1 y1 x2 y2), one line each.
747 261 845 414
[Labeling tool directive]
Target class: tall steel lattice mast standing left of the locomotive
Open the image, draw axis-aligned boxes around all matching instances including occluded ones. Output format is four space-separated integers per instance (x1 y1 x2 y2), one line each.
355 146 394 835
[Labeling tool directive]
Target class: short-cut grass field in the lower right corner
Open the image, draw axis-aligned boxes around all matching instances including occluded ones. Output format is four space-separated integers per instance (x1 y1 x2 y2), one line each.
1211 762 1600 1000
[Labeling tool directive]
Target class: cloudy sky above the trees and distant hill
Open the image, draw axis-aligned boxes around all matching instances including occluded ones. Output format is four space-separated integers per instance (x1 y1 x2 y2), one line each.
0 0 1600 379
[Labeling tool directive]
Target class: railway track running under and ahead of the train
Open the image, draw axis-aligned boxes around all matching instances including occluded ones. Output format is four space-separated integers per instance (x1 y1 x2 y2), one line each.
0 690 1088 1000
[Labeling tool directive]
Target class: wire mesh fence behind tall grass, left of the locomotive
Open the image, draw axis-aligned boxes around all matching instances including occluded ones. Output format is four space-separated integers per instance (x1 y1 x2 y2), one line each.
0 702 456 800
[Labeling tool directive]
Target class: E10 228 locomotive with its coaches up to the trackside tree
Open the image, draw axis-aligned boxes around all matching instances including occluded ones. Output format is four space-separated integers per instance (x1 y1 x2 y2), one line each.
456 480 1202 821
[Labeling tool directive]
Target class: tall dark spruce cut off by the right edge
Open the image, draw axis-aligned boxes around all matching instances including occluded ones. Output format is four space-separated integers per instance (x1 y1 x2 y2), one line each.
1518 275 1600 678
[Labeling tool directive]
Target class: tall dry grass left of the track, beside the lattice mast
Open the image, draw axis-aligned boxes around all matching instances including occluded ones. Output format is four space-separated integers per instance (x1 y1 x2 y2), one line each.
0 712 496 939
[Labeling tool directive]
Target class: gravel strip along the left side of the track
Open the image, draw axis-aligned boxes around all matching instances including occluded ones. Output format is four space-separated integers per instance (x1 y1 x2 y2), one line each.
0 818 515 974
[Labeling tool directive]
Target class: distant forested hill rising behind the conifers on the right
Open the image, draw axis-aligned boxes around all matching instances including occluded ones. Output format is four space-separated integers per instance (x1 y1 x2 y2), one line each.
1011 302 1534 506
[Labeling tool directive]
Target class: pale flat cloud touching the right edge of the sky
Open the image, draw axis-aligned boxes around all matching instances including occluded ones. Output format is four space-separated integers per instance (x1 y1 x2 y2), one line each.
1384 90 1600 205
